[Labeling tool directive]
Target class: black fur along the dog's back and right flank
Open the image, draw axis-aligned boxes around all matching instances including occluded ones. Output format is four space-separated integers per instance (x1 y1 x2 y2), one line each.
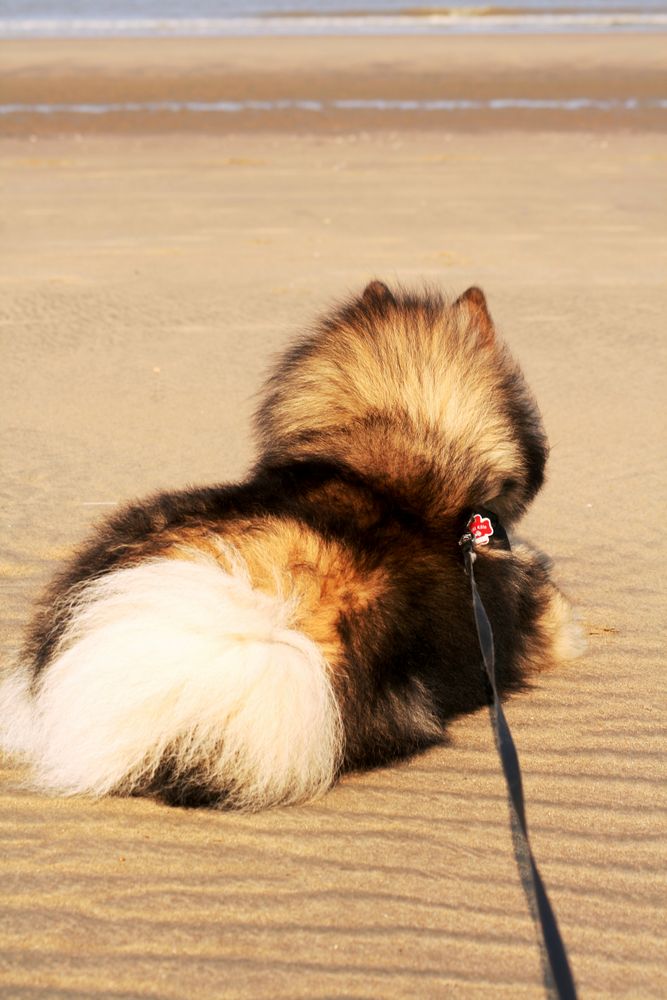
28 461 540 776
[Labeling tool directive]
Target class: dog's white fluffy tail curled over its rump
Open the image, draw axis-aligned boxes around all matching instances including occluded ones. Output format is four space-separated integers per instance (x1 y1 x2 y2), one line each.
0 559 342 809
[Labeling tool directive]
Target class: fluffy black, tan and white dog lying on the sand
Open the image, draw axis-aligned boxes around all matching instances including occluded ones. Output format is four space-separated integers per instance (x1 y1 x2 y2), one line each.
0 281 579 810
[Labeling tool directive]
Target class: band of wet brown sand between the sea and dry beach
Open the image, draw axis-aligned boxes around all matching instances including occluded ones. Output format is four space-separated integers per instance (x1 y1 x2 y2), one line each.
0 35 667 136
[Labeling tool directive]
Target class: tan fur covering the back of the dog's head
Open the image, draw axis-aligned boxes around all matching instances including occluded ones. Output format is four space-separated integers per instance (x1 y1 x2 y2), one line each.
261 289 539 517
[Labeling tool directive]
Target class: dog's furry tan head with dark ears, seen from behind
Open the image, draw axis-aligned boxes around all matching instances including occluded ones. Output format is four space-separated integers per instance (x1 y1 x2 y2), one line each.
258 281 547 523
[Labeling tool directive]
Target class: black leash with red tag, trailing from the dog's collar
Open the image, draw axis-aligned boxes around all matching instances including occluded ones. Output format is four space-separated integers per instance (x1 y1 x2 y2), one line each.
459 511 577 1000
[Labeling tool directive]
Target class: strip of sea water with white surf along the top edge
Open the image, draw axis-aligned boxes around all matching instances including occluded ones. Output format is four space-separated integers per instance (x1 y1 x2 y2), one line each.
0 0 667 38
